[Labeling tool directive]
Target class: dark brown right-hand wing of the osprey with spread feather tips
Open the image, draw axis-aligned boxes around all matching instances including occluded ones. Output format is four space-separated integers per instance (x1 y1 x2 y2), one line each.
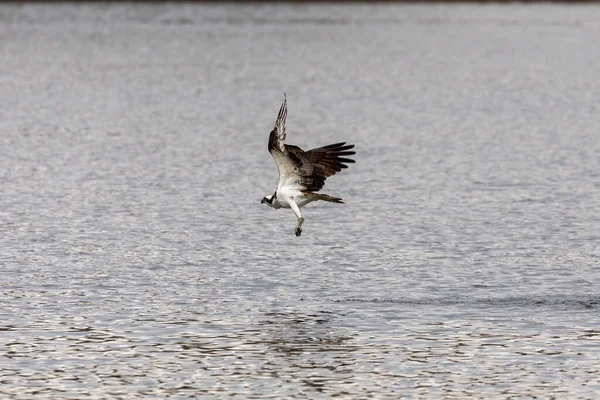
285 142 356 192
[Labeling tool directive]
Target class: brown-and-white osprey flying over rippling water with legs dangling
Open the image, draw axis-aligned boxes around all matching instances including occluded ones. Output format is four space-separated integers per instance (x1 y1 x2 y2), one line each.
261 93 356 236
